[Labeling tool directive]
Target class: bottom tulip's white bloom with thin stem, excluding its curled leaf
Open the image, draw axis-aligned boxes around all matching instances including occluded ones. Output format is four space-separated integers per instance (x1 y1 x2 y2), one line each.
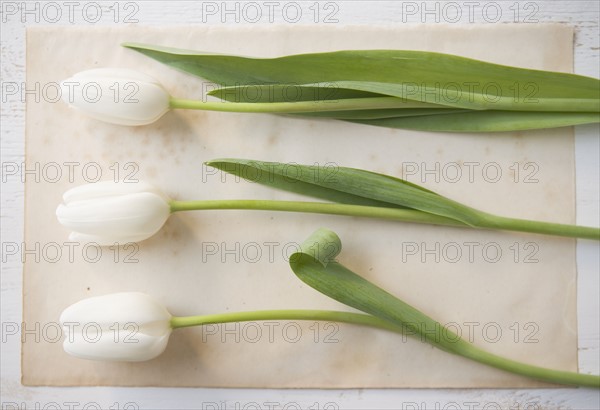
60 292 400 362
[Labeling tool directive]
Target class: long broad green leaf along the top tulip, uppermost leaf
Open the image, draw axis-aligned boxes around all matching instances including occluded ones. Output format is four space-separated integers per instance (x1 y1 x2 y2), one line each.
123 43 600 112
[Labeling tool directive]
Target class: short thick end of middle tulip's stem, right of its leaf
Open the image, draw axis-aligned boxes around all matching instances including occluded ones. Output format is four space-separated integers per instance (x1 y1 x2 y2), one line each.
478 213 600 240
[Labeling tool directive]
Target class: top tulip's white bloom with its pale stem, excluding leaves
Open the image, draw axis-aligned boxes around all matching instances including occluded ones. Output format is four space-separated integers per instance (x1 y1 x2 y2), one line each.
61 68 452 125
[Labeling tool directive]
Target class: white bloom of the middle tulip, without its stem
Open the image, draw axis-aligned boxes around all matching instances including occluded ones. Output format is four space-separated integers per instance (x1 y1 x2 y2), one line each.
56 181 171 246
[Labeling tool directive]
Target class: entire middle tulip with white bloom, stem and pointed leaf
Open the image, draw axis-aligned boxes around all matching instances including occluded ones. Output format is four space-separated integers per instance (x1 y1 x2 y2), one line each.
56 159 600 245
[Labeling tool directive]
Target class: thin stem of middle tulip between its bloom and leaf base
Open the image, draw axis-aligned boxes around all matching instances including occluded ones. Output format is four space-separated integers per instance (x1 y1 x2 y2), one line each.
170 199 466 226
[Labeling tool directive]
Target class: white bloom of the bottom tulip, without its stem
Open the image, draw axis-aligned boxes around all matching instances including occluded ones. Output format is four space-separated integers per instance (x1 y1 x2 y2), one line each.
60 292 172 362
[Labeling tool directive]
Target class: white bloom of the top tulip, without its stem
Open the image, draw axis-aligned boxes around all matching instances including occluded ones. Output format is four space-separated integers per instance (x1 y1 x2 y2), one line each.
61 68 171 125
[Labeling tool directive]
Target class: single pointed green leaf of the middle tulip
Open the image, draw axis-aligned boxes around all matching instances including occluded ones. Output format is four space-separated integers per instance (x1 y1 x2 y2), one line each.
206 158 482 226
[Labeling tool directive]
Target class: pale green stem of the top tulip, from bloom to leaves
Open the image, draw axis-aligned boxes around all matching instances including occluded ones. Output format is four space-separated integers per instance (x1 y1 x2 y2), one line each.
170 97 448 114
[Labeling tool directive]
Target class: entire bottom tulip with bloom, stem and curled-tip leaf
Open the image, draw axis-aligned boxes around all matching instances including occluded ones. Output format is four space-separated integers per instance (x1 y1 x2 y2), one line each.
60 270 600 388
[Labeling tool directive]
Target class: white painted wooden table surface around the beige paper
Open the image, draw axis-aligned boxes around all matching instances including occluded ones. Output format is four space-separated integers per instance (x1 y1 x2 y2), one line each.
0 0 600 410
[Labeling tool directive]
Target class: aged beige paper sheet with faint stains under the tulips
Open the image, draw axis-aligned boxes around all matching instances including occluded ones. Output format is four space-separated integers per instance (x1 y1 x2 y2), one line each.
22 25 577 388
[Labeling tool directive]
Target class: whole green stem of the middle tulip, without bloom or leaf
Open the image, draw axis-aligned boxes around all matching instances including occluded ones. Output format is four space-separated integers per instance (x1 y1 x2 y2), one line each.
170 199 600 240
